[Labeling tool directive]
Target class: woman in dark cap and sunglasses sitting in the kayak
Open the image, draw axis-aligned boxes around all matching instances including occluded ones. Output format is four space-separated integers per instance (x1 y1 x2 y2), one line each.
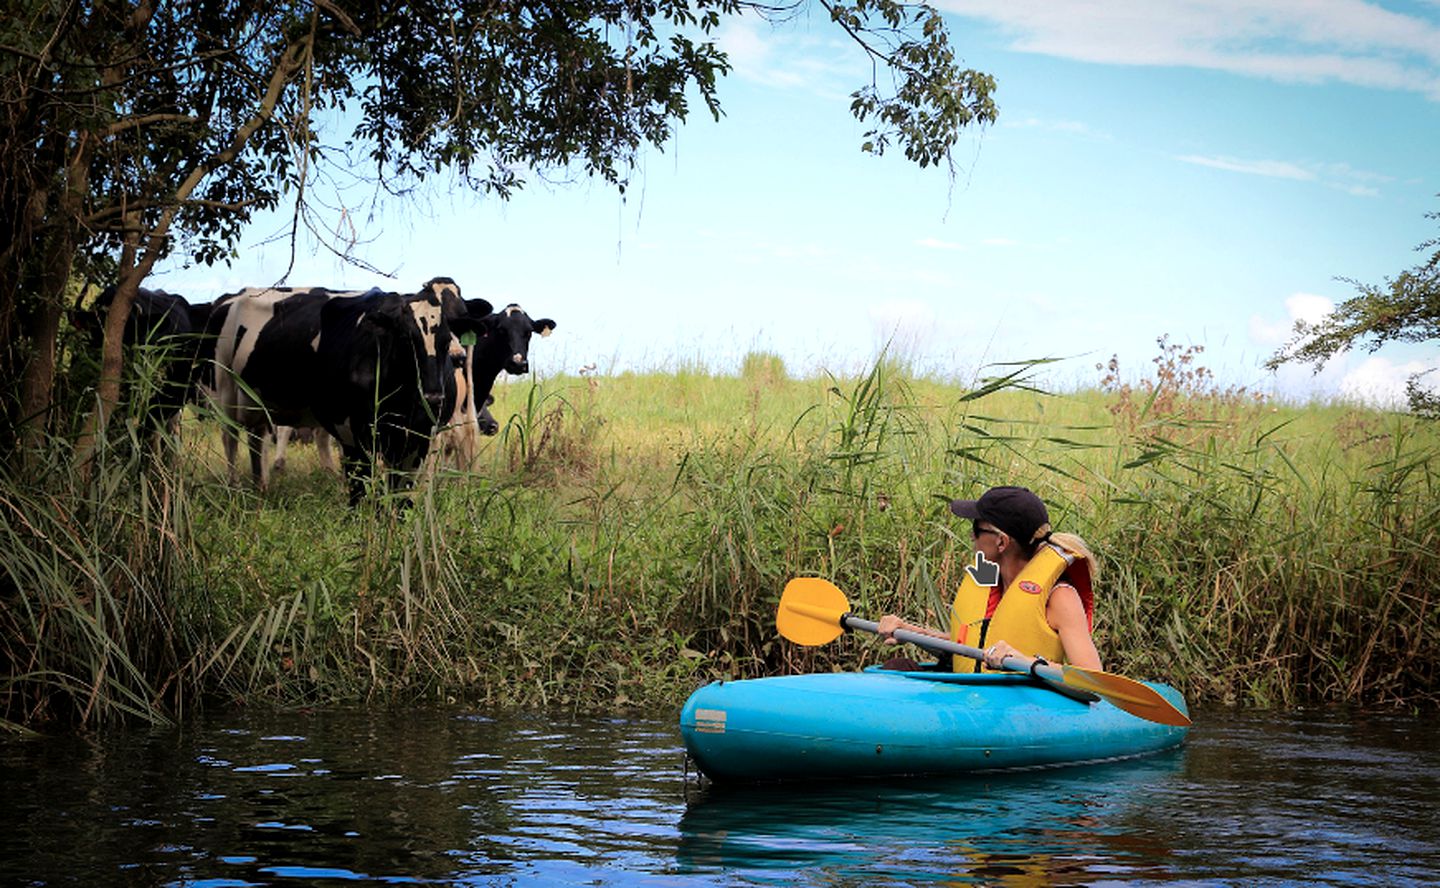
878 486 1100 672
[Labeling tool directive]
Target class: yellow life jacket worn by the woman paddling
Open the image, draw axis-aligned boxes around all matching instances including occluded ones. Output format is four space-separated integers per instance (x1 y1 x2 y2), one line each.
950 543 1094 672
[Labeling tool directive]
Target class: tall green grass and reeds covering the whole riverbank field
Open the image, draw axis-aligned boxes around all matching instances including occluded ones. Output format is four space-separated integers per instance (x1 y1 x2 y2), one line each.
0 350 1440 725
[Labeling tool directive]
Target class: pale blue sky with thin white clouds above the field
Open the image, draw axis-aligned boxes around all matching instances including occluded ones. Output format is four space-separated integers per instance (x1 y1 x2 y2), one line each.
150 0 1440 404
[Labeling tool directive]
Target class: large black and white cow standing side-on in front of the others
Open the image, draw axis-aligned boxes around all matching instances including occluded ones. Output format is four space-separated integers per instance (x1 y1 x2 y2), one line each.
210 280 480 504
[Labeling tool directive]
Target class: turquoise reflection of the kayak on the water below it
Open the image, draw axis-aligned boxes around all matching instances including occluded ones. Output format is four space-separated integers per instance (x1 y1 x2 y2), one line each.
677 750 1185 885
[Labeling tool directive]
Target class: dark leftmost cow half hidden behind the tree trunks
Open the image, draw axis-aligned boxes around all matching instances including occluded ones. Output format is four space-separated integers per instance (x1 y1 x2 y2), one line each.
72 285 210 430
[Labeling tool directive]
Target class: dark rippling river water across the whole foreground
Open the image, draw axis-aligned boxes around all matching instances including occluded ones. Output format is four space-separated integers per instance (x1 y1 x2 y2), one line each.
0 710 1440 887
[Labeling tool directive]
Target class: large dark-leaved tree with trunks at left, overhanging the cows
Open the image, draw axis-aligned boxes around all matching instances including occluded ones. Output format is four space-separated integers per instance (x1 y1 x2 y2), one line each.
0 0 996 450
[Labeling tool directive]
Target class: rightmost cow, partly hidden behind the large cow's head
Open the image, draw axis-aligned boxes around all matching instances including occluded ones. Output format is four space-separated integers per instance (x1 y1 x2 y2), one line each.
439 299 556 469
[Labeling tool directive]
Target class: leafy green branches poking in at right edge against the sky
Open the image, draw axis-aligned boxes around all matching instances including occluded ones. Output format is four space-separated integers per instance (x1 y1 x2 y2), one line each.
1266 205 1440 419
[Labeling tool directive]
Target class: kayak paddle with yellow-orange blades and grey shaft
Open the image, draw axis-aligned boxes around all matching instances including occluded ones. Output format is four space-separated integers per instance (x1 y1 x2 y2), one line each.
775 577 1191 727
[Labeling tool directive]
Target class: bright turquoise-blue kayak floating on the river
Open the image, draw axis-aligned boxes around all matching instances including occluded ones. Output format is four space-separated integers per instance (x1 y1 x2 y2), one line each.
680 668 1189 781
